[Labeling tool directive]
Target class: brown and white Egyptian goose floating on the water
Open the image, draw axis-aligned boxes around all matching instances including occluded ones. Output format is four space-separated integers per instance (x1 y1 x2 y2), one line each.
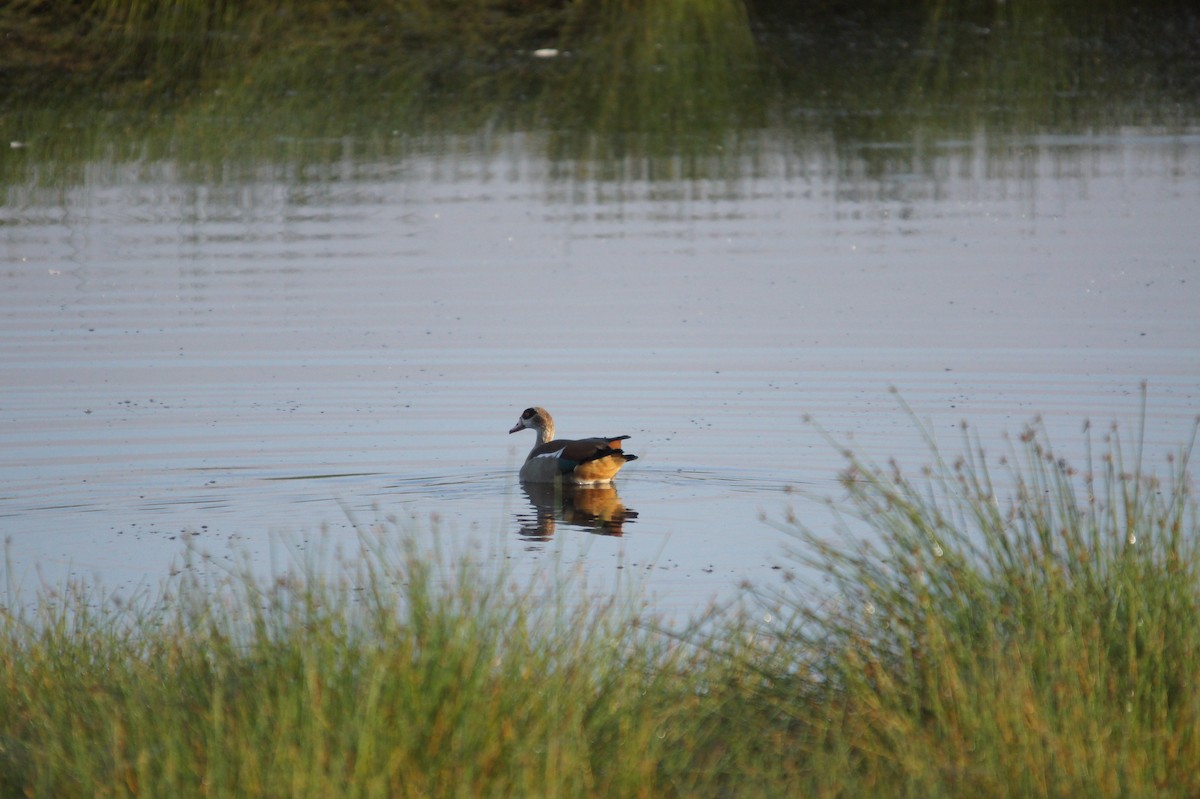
509 408 637 483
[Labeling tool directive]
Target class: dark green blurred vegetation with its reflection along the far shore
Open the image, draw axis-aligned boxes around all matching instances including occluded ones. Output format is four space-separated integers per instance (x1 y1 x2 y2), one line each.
0 0 1200 182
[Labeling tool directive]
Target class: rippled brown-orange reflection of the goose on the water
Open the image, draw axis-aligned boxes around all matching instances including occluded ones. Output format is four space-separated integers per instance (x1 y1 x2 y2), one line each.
516 481 637 541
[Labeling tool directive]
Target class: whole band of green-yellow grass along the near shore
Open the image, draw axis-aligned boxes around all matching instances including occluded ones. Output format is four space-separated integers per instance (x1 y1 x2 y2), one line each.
0 412 1200 797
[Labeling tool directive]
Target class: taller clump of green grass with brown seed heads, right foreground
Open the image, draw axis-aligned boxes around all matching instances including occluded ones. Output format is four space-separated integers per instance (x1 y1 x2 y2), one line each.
764 400 1200 795
